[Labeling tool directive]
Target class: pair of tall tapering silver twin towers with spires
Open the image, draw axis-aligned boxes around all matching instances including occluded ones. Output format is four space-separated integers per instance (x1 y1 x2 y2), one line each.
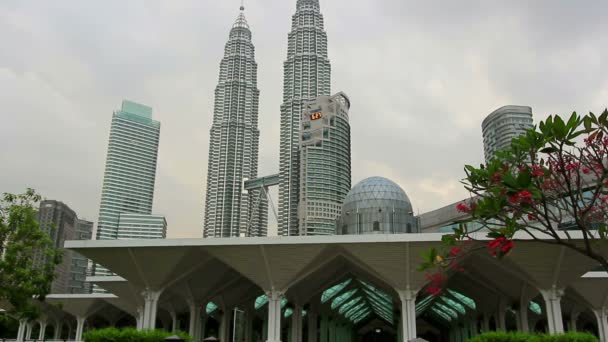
204 0 331 237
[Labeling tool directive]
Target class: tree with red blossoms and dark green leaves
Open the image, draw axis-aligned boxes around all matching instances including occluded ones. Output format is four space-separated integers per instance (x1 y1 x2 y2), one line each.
420 110 608 294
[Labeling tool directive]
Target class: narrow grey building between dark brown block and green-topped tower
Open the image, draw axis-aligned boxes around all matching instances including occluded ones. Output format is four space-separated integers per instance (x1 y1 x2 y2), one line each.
68 219 93 293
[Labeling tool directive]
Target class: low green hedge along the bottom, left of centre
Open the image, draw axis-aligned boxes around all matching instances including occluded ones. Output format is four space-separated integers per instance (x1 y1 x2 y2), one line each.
83 328 192 342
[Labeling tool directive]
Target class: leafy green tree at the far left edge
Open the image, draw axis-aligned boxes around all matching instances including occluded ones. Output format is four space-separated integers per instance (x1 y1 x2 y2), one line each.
0 189 61 318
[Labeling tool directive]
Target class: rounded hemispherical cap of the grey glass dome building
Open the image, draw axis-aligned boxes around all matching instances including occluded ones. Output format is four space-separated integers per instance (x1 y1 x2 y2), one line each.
343 177 412 213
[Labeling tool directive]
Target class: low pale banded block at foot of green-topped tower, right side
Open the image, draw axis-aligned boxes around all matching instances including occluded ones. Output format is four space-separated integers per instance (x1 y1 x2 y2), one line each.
118 213 167 240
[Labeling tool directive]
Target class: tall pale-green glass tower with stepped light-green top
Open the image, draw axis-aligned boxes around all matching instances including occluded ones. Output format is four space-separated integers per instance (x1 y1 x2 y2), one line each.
97 100 160 240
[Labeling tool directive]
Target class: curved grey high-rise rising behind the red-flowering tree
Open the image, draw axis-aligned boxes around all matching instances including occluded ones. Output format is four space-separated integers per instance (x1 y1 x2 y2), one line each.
481 106 534 163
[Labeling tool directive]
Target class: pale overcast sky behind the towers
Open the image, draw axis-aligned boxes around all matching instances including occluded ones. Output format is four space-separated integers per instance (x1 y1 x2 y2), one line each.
0 0 608 237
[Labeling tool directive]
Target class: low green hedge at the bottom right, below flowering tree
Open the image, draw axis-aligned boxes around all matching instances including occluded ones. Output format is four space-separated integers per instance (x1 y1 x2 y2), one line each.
469 331 598 342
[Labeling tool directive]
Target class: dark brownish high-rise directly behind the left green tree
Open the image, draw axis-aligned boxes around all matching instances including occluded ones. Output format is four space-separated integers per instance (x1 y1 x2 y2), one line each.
38 200 78 293
